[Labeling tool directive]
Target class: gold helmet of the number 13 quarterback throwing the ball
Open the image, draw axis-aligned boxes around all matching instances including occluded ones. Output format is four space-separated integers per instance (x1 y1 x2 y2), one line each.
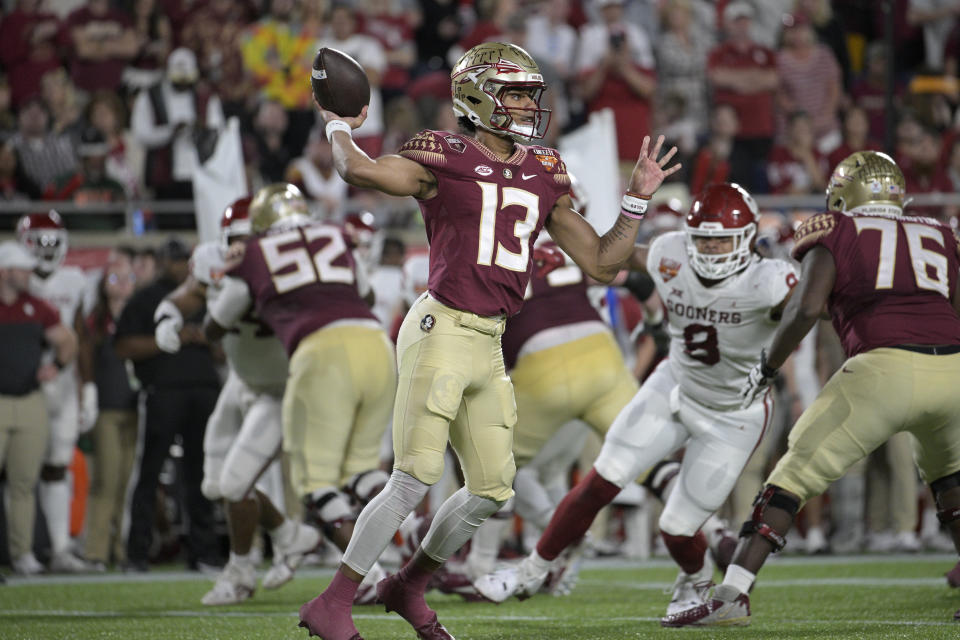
450 42 550 142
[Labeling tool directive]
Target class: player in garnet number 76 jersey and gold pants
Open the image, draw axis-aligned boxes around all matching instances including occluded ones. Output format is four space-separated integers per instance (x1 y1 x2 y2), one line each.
667 151 960 627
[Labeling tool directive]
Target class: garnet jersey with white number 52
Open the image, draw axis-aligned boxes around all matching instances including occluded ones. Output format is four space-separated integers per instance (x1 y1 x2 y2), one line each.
228 223 377 355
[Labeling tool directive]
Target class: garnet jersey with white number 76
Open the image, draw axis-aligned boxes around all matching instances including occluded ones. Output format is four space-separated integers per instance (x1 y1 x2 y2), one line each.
793 211 960 358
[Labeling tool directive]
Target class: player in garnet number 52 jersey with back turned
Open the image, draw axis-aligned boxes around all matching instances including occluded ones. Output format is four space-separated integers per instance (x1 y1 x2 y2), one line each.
205 183 397 603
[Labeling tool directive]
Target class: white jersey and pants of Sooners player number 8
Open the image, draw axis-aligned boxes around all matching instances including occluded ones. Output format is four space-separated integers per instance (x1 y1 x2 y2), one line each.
594 232 797 536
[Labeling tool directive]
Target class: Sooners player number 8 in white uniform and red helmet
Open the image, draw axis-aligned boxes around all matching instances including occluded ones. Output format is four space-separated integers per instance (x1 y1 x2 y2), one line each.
475 184 797 615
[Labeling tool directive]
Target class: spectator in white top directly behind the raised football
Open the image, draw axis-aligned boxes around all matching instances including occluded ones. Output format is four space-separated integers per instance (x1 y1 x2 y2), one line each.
316 4 387 158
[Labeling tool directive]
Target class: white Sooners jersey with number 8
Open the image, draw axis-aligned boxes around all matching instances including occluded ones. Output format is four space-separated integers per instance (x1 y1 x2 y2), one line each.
647 231 797 409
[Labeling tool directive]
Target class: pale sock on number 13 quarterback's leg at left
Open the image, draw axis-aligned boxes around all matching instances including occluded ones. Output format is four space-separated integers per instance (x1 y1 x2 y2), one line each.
343 469 430 576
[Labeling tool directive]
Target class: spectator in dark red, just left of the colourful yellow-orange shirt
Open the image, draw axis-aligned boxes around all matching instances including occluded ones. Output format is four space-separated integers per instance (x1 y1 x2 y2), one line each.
180 0 257 115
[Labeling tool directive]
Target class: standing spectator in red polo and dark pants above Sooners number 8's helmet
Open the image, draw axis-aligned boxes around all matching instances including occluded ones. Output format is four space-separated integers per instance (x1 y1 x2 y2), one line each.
707 0 780 193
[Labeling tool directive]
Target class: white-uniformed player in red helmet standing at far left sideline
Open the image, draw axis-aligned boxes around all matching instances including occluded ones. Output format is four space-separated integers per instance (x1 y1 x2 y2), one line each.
17 209 97 573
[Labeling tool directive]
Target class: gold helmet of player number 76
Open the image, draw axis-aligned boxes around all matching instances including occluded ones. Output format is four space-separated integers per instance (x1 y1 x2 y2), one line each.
827 151 907 215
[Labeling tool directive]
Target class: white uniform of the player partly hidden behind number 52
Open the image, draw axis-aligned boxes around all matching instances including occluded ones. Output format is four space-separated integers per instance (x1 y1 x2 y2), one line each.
191 242 287 502
